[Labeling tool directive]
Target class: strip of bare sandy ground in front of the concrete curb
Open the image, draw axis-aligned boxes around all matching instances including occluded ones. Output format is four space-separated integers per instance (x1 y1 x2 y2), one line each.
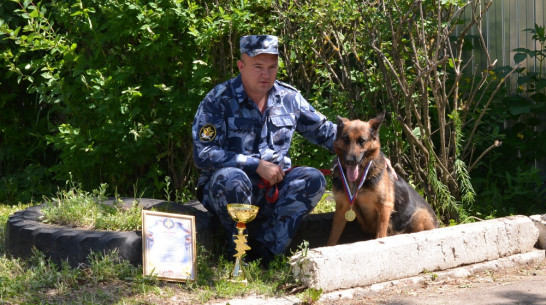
318 260 546 305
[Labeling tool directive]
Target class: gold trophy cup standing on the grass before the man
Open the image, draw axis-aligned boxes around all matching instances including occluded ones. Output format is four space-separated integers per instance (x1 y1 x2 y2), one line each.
227 203 259 283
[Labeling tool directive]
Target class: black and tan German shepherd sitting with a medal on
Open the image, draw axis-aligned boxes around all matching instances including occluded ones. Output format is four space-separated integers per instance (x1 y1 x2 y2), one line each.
327 111 438 246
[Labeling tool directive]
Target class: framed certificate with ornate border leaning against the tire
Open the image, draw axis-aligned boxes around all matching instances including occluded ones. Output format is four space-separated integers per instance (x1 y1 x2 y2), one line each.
142 210 196 281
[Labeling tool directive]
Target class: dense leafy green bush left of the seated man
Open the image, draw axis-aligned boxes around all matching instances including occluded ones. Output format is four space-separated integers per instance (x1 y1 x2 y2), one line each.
0 0 276 201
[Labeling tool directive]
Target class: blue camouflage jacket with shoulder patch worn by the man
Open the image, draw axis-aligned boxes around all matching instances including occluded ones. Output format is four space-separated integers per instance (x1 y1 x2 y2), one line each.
192 75 337 185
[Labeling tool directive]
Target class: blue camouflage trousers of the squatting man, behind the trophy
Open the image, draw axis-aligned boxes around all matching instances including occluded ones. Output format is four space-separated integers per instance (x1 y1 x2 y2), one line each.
202 167 326 261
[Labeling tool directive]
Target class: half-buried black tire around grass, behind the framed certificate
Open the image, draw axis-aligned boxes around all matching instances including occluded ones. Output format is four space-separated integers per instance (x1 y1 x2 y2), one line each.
6 198 217 267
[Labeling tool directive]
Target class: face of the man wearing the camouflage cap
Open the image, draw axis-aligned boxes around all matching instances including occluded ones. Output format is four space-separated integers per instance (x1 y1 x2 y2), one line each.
237 54 279 98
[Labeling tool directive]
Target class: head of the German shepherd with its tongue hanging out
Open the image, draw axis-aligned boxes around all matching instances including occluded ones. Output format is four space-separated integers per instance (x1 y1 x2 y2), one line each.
334 111 385 181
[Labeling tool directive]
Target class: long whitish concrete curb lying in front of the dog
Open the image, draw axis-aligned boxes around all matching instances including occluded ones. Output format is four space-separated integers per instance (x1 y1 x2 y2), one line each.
290 216 539 292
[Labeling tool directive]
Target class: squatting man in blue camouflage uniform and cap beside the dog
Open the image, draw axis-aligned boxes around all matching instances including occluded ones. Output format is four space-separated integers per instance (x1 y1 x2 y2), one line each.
192 35 337 264
